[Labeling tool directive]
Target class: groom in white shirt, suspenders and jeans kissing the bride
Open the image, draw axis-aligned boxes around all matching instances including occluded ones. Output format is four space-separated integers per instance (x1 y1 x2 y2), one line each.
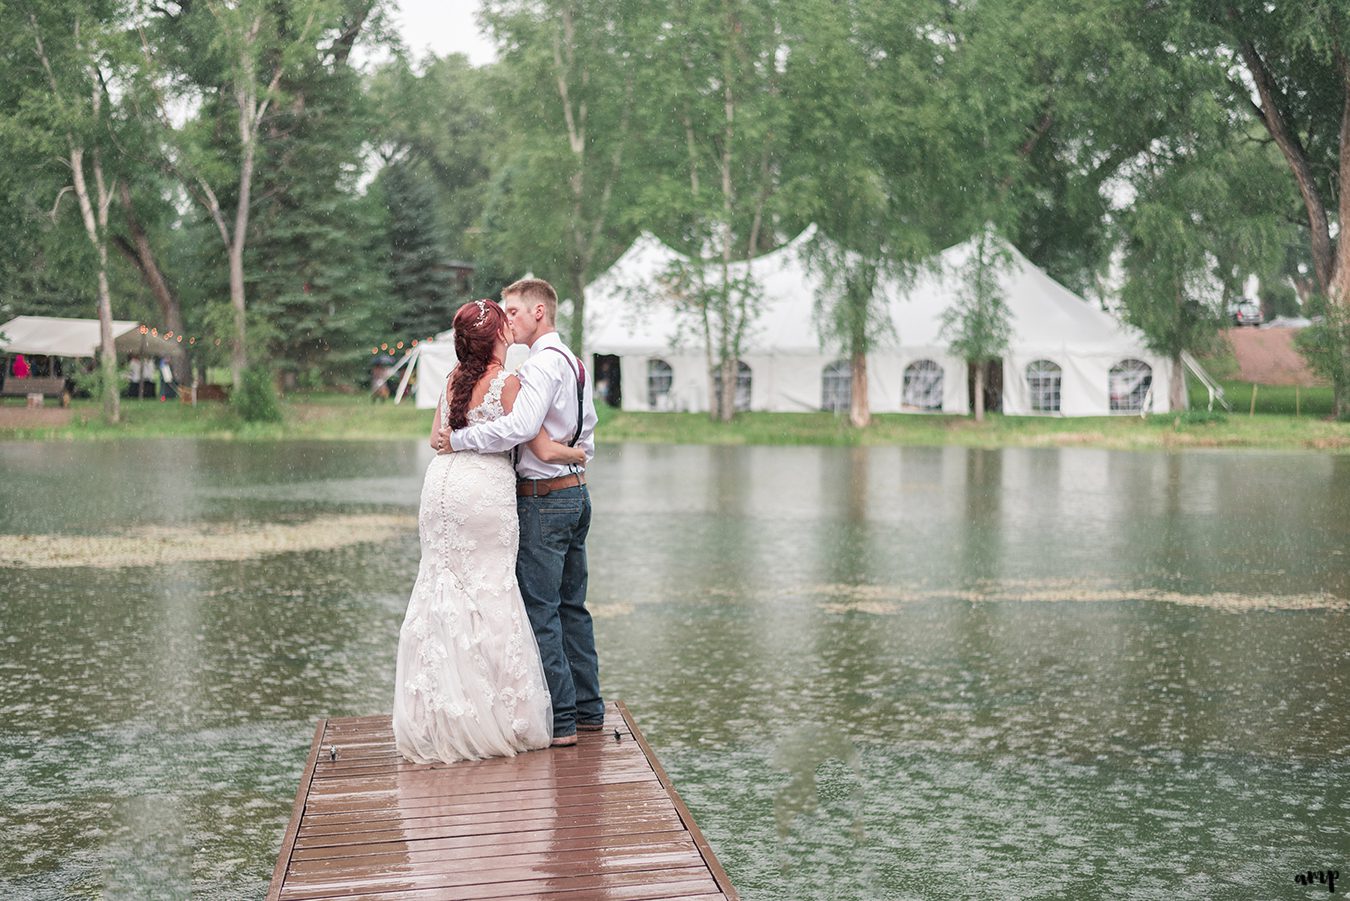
440 278 605 746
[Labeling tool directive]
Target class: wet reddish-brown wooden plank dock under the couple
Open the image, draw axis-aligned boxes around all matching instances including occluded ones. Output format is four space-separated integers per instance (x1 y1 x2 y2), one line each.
267 702 737 901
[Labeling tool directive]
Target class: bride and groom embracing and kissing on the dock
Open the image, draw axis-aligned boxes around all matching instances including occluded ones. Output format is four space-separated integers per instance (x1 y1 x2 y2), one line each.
393 278 605 763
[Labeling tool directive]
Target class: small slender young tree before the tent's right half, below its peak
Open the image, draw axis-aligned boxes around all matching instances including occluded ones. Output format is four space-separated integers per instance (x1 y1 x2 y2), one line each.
942 227 1013 423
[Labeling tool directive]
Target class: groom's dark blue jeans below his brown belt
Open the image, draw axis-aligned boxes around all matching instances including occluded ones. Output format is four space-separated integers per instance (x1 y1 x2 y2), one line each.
516 485 605 738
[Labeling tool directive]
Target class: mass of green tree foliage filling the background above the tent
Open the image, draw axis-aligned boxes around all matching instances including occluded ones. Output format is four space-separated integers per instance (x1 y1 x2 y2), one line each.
0 0 1350 405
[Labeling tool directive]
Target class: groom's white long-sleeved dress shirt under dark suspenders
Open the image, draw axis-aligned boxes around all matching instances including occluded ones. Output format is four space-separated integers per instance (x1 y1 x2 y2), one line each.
450 331 595 478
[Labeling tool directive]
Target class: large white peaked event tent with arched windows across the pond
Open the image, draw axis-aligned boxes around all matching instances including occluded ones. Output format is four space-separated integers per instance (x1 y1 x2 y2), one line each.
586 226 1172 416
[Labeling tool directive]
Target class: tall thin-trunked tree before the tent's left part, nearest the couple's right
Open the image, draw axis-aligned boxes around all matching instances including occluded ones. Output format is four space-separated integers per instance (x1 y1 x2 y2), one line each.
636 0 791 420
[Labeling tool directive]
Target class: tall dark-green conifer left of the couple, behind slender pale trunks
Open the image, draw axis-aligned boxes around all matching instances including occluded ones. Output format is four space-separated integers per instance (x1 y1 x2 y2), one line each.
248 9 394 388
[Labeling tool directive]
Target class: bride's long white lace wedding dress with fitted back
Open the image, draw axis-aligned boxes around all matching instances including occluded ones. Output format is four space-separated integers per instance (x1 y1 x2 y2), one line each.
394 373 554 763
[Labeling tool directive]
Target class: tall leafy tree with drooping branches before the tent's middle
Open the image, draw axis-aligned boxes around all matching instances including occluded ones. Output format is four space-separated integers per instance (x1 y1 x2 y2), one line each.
783 0 936 428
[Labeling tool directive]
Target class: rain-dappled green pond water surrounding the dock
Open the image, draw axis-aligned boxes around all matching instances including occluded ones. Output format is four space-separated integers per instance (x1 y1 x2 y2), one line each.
0 442 1350 901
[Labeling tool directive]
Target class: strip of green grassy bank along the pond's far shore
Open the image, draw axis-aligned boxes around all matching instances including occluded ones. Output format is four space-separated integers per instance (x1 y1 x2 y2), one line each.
0 381 1350 453
